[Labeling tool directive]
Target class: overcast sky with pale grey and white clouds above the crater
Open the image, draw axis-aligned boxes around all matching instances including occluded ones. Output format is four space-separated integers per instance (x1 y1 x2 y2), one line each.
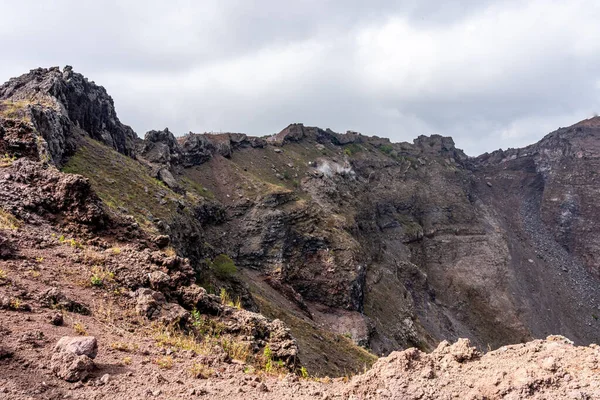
0 0 600 155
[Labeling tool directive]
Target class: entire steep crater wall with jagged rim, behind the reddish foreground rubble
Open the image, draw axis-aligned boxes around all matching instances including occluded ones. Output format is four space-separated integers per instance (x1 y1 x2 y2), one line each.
0 68 600 374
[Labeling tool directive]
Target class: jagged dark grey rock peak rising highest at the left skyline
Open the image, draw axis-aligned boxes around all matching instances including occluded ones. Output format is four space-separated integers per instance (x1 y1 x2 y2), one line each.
0 66 137 164
